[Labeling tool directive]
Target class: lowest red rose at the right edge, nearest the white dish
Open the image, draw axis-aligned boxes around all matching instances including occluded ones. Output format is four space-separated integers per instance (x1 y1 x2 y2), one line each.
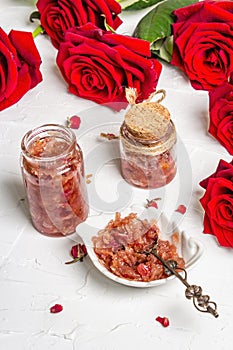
200 160 233 247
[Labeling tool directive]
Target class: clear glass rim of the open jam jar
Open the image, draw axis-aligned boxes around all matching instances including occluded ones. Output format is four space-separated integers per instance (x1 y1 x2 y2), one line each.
21 123 76 162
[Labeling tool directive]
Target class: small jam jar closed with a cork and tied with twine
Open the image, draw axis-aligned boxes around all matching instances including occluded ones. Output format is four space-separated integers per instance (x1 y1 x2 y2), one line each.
120 90 177 189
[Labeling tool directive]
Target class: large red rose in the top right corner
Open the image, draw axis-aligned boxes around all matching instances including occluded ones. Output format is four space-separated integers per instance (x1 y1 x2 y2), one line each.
171 0 233 91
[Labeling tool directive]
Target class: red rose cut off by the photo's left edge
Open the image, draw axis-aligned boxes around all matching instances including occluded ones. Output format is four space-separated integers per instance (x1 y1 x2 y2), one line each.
0 28 42 111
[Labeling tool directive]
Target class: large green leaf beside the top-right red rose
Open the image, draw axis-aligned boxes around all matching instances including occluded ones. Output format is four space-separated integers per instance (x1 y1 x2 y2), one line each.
133 0 198 43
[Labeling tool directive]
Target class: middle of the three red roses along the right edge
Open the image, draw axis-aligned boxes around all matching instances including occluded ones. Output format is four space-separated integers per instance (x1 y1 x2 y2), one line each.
209 83 233 155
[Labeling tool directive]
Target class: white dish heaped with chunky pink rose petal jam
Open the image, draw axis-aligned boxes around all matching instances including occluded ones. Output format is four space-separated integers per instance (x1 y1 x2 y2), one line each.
77 213 203 287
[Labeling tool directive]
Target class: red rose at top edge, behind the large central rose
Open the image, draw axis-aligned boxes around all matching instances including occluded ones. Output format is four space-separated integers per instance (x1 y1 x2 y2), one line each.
36 0 122 48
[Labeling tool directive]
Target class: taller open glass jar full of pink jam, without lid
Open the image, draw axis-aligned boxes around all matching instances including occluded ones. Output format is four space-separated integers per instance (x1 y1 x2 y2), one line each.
21 124 89 236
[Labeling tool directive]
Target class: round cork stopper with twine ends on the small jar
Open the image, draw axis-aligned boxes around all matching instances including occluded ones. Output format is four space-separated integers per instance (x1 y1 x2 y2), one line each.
125 88 170 140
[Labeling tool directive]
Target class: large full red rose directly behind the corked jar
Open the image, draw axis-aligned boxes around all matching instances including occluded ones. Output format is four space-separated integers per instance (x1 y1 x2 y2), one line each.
57 23 162 110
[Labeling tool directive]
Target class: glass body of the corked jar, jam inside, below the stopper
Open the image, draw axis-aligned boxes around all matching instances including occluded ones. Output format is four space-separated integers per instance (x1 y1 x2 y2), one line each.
120 124 177 189
